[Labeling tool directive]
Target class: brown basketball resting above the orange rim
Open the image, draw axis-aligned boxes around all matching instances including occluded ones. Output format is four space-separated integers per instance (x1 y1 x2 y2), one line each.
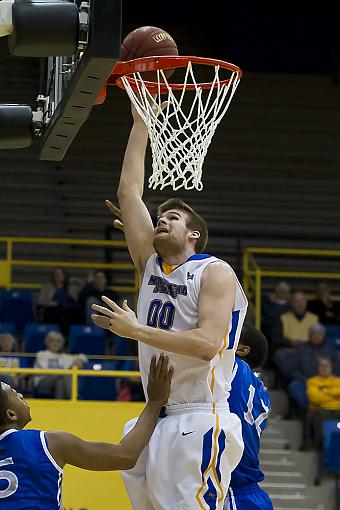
120 26 178 81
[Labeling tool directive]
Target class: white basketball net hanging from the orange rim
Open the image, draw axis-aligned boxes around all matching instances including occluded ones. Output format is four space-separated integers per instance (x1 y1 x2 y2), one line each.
122 62 240 191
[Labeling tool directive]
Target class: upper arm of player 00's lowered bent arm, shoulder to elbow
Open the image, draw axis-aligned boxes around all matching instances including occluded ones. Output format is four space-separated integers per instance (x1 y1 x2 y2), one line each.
198 262 236 359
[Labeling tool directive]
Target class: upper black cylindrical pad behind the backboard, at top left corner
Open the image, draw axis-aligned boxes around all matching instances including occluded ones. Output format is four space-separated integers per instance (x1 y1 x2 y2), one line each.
8 0 79 57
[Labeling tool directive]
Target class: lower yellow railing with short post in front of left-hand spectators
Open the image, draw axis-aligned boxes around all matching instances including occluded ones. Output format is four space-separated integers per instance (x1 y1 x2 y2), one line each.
0 367 140 402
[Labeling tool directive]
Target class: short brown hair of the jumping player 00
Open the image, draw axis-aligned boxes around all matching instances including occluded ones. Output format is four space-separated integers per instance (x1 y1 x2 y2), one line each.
157 198 208 253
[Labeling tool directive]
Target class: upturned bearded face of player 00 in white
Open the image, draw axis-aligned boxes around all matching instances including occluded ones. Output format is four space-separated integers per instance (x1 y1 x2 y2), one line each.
153 209 191 256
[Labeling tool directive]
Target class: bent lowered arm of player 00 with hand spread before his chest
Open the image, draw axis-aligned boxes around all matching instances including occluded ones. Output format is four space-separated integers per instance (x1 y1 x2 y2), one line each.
92 262 236 361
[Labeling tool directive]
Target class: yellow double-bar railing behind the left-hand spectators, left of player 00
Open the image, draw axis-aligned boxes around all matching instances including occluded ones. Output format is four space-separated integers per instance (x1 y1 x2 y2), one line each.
0 237 138 297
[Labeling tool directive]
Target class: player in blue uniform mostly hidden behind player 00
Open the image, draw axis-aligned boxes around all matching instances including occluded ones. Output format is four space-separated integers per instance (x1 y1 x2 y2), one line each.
224 323 273 510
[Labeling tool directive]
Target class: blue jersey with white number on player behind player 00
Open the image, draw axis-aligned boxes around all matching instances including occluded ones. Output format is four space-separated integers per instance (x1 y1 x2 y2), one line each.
228 358 270 489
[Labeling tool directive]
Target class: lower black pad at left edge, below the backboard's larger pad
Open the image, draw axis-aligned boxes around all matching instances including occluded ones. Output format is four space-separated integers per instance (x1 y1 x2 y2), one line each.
0 104 33 149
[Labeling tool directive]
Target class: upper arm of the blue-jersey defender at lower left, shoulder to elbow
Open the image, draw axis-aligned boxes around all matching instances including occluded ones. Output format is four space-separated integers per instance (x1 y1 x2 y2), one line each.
46 431 136 471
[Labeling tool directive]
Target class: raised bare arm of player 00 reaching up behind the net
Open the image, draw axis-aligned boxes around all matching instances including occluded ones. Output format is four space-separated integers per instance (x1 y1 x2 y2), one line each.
117 106 154 272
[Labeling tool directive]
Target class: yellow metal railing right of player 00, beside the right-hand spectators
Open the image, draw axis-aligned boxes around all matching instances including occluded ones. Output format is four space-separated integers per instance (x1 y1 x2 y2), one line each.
243 248 340 328
